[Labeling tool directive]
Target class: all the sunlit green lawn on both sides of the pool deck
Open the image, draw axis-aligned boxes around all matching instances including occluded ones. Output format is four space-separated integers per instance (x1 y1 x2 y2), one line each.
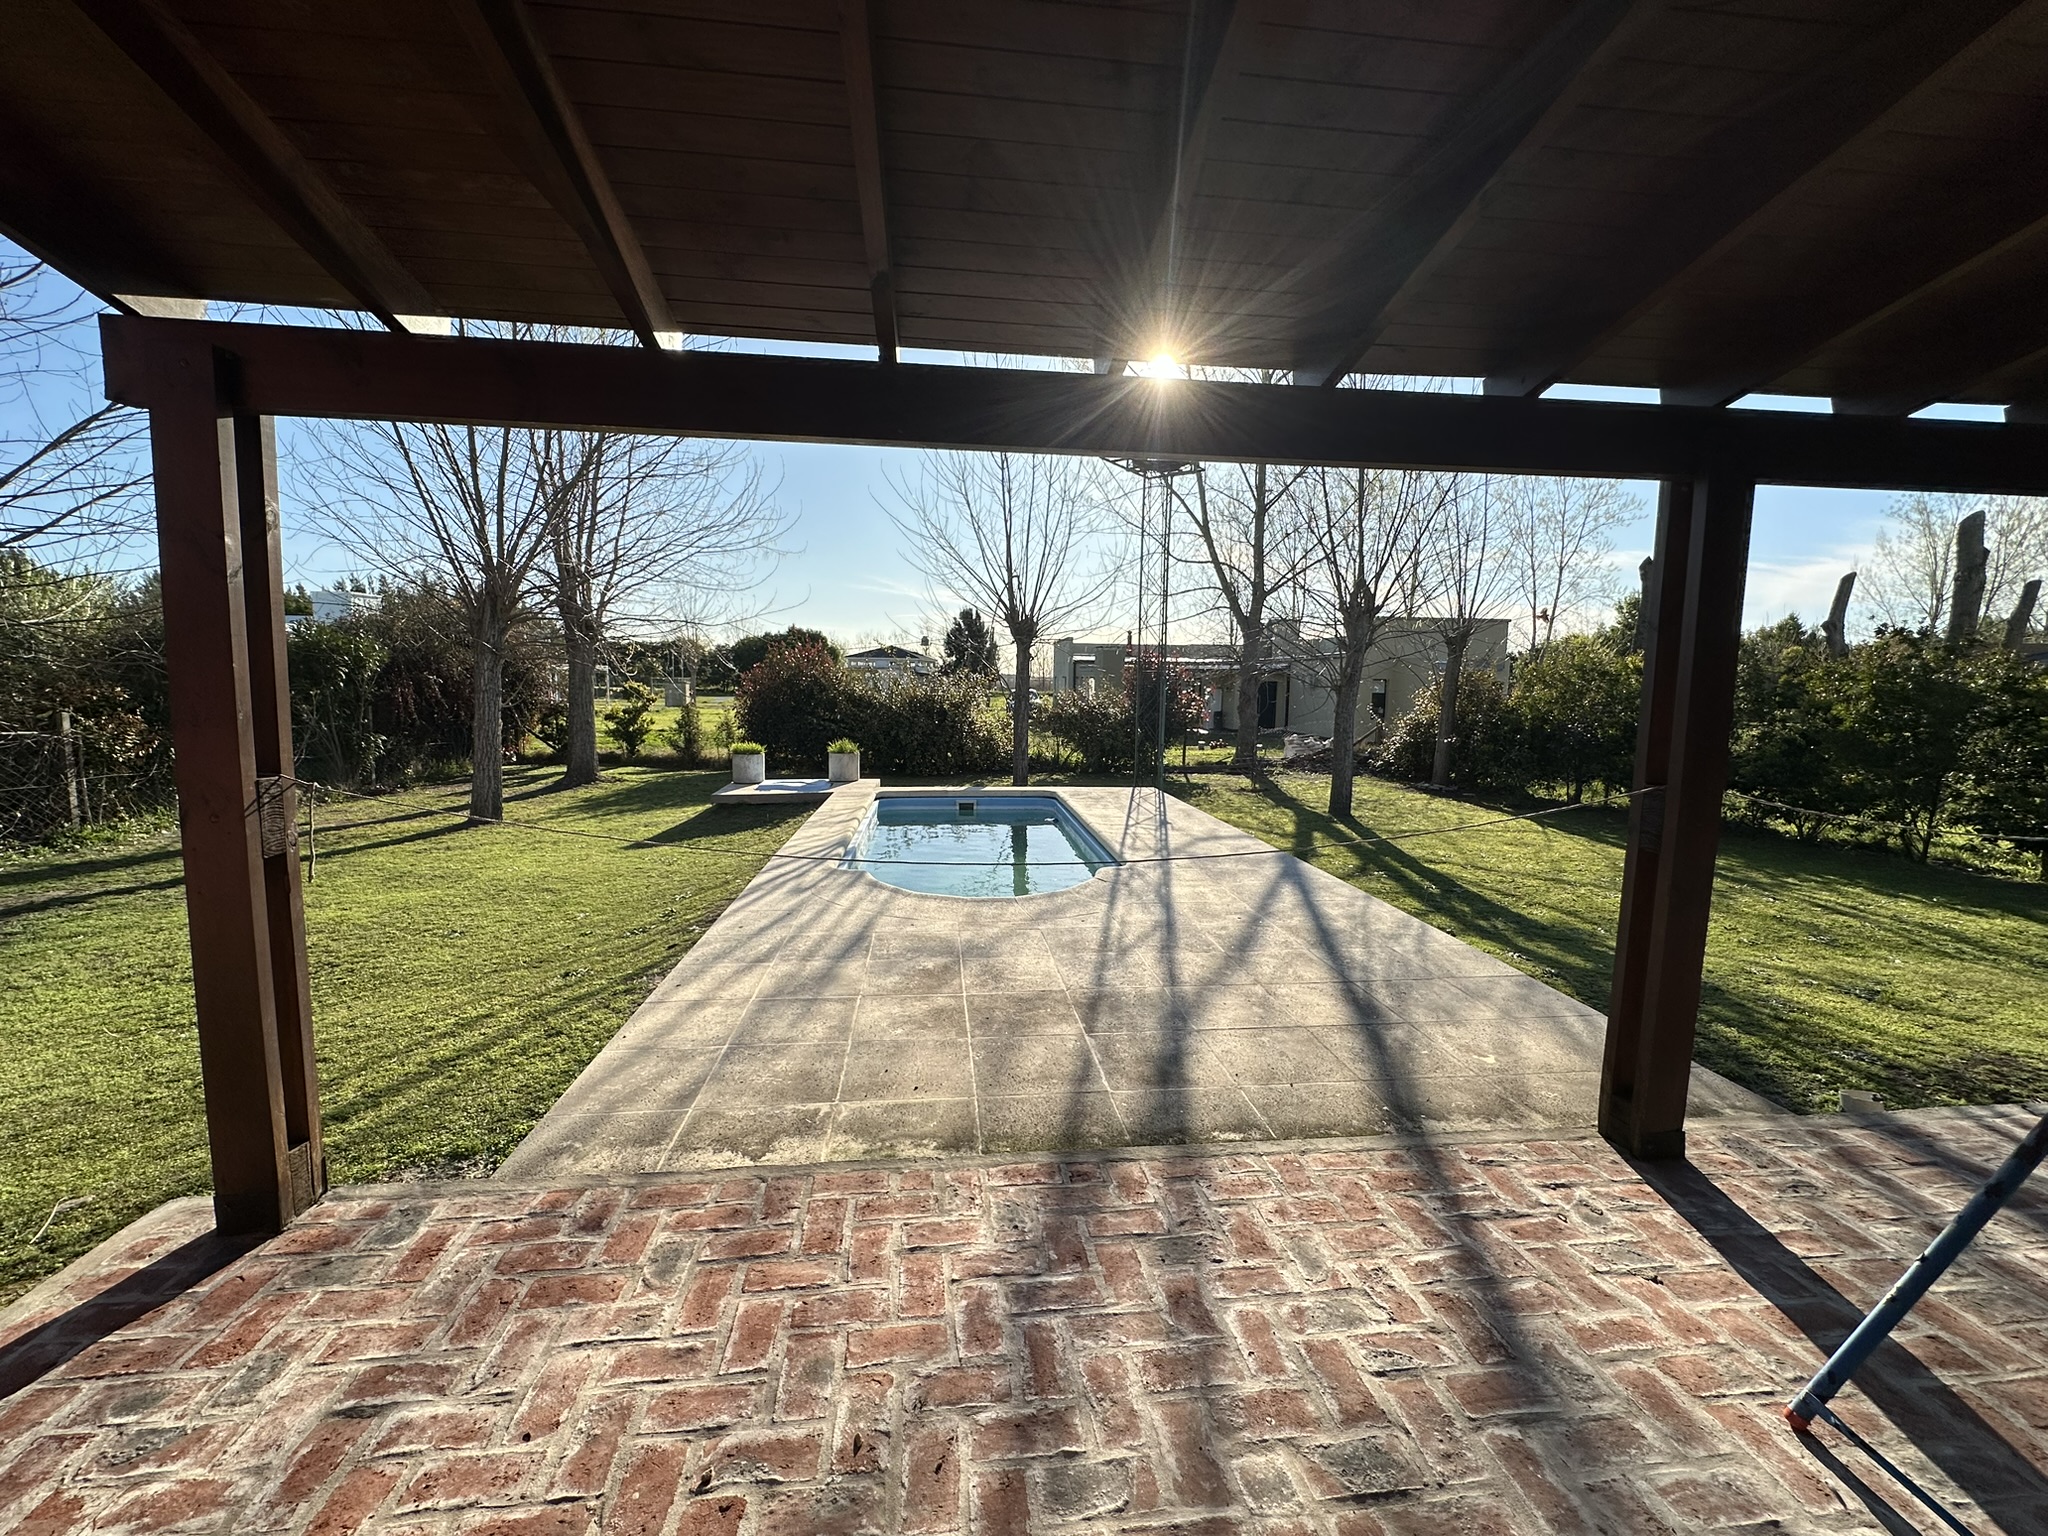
0 768 2048 1300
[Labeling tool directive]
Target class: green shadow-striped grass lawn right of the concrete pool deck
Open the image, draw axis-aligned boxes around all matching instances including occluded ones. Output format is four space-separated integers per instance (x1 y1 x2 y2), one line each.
1182 774 2048 1110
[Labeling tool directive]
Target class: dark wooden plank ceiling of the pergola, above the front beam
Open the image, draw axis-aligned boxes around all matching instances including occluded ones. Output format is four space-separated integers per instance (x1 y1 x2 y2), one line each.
0 0 2048 414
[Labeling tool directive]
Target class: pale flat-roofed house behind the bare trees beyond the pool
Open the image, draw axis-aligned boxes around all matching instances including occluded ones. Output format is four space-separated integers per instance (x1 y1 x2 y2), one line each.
1053 618 1509 741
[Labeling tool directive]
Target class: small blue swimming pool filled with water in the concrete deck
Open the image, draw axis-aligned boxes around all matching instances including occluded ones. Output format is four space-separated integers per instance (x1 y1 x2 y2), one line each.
846 795 1116 897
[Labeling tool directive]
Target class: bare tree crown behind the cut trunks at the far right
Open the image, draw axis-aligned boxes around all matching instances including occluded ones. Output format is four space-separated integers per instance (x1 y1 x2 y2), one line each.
1858 492 2048 633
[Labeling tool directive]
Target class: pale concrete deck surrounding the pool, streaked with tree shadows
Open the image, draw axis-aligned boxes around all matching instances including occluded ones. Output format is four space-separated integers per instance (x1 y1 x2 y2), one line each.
502 780 1776 1180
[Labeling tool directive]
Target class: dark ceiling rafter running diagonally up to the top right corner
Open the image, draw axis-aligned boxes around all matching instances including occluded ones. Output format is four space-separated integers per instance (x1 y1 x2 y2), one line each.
1487 0 2023 395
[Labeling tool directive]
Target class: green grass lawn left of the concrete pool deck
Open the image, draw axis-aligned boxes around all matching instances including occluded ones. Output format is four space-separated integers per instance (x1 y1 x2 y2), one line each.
0 768 799 1303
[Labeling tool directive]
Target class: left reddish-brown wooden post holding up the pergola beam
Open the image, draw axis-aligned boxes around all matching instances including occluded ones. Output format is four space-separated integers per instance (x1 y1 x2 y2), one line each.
150 346 324 1233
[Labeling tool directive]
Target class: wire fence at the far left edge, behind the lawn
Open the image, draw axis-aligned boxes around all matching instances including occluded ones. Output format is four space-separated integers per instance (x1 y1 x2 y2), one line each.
0 717 176 844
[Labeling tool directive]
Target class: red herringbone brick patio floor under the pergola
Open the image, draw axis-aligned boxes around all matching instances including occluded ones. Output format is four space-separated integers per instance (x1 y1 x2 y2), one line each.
0 1110 2048 1536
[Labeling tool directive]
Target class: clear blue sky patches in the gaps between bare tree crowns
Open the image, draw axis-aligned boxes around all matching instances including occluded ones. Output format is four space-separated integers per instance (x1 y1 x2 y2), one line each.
0 237 1916 641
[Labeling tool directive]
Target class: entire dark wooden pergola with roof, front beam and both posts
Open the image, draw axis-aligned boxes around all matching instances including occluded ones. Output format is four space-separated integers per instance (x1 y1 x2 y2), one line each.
0 0 2048 1231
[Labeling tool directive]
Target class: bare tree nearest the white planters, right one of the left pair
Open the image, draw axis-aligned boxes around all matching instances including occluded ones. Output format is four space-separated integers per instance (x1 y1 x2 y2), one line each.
541 432 788 786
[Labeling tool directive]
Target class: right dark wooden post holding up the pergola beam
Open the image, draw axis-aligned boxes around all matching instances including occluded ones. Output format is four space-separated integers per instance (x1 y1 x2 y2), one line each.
1599 471 1755 1157
